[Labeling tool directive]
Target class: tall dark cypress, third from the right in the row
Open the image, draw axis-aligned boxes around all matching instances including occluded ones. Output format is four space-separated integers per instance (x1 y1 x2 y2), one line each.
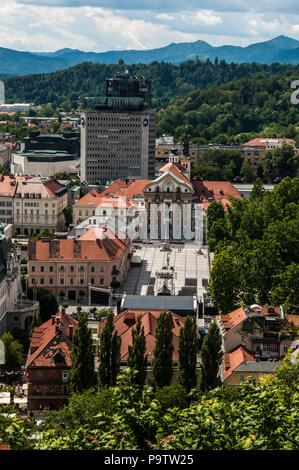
152 312 174 387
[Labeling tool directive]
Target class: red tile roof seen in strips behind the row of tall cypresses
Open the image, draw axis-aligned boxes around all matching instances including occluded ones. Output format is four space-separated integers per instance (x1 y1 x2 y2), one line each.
98 310 185 362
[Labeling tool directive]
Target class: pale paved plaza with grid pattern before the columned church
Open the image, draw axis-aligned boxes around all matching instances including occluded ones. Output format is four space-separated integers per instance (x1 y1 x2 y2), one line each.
122 243 209 299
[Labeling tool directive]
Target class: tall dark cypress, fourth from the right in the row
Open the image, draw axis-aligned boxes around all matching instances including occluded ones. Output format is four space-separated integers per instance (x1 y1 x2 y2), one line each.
128 315 147 386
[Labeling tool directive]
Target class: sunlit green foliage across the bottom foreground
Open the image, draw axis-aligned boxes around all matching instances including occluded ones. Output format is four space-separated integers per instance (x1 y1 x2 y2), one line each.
0 356 299 450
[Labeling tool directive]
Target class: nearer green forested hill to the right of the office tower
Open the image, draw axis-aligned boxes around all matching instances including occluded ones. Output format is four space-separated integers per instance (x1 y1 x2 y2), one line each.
157 67 299 144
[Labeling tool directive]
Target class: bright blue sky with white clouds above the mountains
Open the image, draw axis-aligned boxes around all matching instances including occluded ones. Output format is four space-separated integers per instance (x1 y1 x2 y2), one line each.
0 0 299 52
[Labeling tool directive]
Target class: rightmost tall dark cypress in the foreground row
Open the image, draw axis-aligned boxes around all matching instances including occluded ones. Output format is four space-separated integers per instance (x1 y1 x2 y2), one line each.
200 323 223 391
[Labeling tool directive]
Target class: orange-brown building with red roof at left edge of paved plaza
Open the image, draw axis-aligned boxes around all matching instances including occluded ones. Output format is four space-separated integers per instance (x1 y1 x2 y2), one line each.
28 227 131 300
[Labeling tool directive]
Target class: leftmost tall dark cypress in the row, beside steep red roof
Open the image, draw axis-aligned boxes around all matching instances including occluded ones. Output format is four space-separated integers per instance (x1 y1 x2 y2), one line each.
70 313 96 393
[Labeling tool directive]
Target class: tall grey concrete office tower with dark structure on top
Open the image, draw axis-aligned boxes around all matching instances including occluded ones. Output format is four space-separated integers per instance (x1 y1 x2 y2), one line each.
81 72 156 184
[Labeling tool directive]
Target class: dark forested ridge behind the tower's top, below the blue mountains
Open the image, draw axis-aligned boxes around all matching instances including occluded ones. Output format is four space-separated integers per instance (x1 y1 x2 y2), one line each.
4 60 299 111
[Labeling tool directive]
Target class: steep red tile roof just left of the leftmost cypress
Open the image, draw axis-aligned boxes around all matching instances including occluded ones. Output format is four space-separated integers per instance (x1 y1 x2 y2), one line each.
26 312 78 370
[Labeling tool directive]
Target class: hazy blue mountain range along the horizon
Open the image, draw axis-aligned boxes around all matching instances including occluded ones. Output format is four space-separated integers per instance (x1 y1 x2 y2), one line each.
0 36 299 76
